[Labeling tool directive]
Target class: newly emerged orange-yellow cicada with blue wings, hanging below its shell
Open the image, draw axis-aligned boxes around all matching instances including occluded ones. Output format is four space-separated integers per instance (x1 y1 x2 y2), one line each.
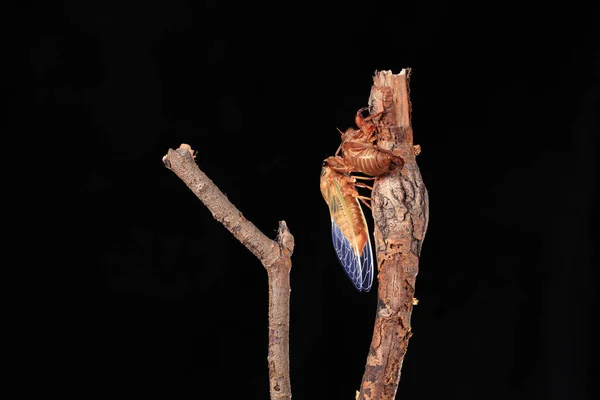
321 157 373 292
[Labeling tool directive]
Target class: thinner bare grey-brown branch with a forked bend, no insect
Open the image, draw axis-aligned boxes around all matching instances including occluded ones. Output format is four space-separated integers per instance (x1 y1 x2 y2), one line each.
163 144 294 400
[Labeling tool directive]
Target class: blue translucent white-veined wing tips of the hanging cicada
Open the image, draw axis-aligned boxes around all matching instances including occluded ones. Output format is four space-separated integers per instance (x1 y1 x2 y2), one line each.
331 220 373 292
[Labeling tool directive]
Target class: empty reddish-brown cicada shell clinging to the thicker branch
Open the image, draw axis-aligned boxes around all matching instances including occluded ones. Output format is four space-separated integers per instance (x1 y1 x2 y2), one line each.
336 108 404 176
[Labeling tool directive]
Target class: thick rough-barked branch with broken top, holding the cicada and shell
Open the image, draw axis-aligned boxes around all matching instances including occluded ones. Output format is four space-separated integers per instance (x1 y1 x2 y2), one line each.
358 70 429 400
